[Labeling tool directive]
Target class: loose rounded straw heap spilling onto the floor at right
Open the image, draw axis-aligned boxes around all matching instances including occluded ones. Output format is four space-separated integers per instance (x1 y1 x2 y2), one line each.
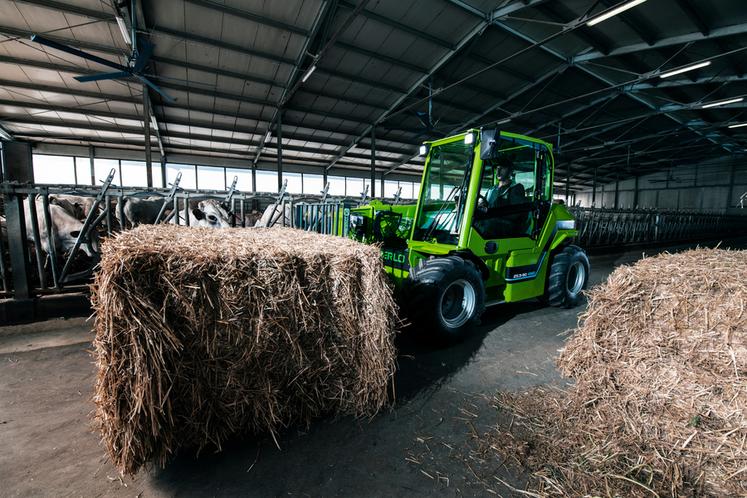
486 249 747 496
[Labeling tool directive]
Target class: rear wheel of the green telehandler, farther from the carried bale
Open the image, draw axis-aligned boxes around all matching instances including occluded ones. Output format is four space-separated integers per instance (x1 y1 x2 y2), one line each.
546 245 591 308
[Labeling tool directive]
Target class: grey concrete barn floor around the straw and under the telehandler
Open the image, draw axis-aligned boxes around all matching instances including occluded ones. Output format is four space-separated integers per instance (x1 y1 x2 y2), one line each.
0 240 747 497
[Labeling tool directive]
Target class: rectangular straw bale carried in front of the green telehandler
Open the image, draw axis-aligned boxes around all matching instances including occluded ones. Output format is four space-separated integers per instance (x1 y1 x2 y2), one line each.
92 225 396 474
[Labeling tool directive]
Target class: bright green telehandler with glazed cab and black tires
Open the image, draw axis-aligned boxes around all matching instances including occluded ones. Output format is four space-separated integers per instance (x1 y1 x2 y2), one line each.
345 129 590 341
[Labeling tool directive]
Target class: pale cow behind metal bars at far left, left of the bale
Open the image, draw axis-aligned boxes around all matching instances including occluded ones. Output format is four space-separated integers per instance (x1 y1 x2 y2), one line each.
0 198 98 258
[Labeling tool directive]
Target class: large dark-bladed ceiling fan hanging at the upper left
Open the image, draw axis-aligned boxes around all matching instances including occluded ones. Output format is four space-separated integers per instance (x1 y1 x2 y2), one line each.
31 0 175 103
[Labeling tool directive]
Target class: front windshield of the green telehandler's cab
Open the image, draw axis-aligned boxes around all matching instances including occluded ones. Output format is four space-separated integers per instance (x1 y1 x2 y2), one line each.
414 140 473 244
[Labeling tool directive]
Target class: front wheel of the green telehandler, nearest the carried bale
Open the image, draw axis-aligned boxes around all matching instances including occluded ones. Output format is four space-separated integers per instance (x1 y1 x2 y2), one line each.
407 256 485 343
